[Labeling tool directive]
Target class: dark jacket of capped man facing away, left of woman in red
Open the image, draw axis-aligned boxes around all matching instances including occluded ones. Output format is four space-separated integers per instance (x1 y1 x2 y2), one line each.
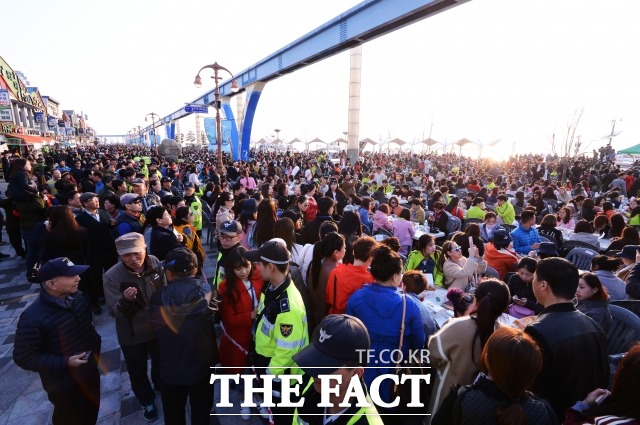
151 277 218 385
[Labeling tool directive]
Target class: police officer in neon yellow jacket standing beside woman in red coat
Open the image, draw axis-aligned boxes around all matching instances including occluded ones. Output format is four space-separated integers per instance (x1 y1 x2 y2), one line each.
245 238 309 425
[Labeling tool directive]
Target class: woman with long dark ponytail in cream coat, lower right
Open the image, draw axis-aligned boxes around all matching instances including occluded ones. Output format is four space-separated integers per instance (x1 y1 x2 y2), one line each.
429 279 511 412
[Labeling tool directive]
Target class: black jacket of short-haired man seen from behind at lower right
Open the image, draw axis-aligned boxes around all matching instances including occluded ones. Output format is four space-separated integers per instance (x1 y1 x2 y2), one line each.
525 302 609 417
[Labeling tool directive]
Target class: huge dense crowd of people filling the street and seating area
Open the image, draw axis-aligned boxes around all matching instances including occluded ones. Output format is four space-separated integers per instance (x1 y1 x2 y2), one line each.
0 146 640 425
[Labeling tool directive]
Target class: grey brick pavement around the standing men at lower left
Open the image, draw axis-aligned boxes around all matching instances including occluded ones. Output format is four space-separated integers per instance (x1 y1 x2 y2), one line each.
0 183 266 425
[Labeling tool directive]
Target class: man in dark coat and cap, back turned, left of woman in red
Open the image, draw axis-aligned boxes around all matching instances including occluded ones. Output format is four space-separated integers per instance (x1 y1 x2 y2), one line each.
151 247 218 424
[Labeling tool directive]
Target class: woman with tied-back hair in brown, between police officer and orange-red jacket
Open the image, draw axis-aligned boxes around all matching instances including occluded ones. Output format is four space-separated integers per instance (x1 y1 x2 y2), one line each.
307 232 347 324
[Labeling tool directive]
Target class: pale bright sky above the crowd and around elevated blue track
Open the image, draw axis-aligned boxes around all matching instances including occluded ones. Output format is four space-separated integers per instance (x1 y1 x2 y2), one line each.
0 0 640 157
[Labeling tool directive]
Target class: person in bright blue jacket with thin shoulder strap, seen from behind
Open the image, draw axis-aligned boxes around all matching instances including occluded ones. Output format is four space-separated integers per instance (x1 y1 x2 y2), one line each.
346 245 426 418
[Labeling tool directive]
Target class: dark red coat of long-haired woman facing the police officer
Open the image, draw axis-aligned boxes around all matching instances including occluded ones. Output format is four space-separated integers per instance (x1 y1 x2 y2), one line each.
218 269 263 373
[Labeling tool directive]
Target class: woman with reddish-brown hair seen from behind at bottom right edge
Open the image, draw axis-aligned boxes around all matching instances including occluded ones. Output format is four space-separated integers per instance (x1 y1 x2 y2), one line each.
431 326 557 425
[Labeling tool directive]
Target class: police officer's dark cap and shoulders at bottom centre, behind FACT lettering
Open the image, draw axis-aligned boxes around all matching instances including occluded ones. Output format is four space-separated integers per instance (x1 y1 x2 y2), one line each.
293 314 382 425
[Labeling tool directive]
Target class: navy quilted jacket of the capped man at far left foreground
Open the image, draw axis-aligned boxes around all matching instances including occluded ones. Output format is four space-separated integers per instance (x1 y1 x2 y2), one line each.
13 291 101 393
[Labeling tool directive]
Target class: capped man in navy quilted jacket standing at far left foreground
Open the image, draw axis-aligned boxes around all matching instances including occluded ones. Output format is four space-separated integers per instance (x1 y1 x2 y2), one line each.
13 258 101 425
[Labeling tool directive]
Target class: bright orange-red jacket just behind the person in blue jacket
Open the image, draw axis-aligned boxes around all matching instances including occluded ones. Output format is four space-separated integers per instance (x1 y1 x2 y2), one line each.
324 263 375 314
